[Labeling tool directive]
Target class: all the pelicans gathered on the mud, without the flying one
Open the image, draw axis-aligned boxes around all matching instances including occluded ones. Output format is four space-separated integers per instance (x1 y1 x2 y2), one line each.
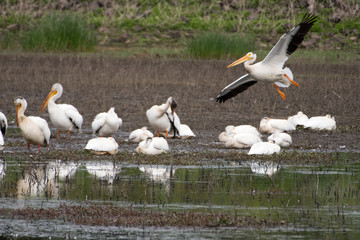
0 83 336 155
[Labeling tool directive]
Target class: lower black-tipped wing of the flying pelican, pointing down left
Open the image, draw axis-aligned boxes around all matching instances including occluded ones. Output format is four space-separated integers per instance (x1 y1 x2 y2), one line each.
216 74 257 103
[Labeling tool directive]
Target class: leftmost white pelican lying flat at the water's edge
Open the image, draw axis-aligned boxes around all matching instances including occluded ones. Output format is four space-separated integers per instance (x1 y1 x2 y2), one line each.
85 137 119 155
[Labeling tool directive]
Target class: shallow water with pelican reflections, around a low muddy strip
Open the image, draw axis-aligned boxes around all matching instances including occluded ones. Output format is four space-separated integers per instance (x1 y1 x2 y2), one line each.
0 157 360 239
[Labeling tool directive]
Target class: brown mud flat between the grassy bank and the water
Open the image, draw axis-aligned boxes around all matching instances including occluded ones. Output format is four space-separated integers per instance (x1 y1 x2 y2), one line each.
0 54 360 160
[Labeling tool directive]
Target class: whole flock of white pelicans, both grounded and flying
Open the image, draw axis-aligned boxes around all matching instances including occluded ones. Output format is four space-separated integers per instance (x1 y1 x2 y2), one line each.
0 14 336 154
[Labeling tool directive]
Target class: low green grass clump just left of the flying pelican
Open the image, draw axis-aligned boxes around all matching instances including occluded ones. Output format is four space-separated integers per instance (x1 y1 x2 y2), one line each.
187 32 254 59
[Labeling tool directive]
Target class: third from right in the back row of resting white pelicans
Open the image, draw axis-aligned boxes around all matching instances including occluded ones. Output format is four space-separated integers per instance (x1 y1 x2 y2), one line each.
259 117 295 133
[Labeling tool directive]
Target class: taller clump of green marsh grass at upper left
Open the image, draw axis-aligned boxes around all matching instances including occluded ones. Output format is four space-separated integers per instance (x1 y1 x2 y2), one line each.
20 13 96 51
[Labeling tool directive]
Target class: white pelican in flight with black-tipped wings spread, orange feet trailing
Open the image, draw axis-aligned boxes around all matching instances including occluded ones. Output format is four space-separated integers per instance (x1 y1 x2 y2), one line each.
216 14 317 103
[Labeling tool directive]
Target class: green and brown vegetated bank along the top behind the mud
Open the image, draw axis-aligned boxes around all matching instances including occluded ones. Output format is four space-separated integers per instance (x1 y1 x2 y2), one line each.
0 0 360 55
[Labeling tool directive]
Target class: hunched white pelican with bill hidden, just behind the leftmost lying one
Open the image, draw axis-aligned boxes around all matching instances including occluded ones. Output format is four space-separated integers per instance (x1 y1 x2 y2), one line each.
91 107 122 137
